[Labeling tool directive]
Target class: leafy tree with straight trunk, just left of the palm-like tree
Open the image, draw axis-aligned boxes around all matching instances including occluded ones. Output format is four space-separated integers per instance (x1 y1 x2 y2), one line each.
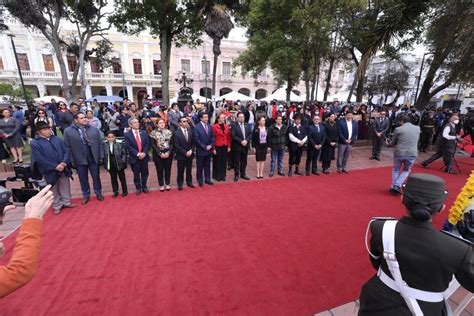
110 0 202 105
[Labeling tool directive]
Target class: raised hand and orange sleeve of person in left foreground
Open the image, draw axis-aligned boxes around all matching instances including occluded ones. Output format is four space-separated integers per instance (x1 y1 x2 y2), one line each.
0 185 53 298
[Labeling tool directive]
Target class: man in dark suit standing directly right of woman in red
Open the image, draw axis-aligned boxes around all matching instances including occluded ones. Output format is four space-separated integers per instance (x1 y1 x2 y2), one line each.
231 112 252 182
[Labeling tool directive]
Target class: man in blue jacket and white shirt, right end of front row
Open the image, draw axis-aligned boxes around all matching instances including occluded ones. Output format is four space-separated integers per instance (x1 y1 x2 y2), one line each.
337 112 357 173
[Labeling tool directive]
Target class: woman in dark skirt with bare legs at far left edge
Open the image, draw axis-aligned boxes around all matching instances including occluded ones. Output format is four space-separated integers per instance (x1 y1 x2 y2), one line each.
0 109 23 163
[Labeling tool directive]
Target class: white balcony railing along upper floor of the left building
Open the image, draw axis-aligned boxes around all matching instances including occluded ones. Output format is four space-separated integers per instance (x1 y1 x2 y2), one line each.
0 70 161 81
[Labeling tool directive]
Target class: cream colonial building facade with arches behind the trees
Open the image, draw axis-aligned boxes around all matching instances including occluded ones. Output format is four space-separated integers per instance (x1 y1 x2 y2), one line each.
0 20 349 102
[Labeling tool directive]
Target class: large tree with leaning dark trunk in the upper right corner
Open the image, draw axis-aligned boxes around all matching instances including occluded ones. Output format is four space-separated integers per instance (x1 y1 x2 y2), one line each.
416 0 474 108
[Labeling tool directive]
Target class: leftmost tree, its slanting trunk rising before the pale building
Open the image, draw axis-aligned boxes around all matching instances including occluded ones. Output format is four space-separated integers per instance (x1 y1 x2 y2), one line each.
4 0 72 100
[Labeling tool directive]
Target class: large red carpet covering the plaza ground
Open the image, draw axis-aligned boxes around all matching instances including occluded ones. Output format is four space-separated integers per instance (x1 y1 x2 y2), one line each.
0 160 472 315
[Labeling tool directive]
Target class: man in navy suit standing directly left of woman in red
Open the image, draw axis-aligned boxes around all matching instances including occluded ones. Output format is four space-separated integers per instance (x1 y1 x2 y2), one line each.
193 112 215 187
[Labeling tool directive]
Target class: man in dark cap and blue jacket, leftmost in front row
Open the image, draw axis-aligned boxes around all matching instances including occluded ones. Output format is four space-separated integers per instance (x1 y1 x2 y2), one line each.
31 122 76 215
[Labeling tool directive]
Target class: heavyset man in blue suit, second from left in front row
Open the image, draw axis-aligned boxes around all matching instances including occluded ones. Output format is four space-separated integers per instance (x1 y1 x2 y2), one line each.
64 112 104 204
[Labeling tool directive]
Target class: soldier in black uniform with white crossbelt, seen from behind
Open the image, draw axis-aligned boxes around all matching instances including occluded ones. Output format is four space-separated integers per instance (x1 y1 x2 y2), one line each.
359 173 474 316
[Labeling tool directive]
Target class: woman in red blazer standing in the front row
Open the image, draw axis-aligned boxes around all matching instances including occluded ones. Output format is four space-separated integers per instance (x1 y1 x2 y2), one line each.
212 113 230 181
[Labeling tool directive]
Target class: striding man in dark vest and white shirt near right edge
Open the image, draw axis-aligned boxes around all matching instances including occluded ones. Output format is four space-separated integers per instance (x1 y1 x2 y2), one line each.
421 114 462 173
